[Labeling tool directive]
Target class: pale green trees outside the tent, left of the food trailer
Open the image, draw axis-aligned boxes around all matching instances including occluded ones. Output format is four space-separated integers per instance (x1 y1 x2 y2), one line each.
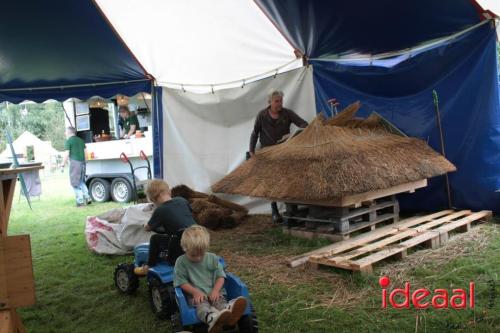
0 102 65 151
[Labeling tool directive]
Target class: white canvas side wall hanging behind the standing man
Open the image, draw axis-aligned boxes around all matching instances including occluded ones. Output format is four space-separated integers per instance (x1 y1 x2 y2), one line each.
163 67 316 212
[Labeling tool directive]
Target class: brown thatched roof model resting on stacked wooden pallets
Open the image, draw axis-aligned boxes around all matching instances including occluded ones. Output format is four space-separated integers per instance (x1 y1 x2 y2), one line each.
212 105 456 202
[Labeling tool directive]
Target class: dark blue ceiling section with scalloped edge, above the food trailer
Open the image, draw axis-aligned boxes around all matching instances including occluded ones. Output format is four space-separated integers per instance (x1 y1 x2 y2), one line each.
0 0 151 103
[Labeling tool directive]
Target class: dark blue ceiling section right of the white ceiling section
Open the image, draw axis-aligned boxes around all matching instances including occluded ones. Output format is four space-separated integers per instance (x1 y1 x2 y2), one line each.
255 0 480 58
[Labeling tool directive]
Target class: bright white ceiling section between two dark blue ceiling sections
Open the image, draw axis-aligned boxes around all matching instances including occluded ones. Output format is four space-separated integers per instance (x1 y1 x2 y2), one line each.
97 0 302 90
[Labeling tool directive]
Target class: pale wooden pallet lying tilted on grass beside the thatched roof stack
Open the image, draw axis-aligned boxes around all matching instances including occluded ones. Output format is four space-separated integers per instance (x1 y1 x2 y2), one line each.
304 210 492 273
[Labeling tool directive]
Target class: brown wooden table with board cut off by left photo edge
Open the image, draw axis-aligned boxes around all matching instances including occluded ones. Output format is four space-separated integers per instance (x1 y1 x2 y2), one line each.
0 166 43 333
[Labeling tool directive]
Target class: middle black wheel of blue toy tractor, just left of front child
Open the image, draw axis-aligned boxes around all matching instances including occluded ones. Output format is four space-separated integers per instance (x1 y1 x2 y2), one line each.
149 278 177 319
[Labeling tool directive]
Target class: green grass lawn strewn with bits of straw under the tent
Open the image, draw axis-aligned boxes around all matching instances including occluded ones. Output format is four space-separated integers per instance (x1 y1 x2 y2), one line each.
8 175 500 333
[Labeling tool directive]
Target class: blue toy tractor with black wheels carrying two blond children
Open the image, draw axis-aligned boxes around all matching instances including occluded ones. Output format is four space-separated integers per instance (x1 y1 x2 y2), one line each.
114 243 259 333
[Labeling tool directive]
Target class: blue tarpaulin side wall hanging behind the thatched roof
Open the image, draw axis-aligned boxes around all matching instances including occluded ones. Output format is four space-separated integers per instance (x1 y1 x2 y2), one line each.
311 25 500 212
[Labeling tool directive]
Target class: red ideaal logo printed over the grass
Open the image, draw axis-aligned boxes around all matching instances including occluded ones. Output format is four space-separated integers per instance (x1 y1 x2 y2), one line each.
379 276 475 309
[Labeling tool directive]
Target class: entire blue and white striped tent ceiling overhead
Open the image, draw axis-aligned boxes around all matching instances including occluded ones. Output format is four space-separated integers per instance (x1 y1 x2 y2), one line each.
0 0 500 102
